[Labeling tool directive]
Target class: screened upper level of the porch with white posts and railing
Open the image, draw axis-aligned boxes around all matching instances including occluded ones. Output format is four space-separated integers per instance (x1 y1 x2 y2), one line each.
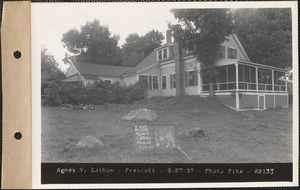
203 62 287 93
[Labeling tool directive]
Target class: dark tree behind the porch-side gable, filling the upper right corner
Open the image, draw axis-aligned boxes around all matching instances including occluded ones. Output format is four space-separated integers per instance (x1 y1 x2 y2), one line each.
233 8 292 68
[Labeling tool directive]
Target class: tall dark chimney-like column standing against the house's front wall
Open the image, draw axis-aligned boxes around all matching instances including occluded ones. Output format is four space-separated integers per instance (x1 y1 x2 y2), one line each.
174 25 185 96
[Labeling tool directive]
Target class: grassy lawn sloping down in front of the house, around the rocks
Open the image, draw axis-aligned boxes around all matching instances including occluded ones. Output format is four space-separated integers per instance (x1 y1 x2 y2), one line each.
42 96 293 163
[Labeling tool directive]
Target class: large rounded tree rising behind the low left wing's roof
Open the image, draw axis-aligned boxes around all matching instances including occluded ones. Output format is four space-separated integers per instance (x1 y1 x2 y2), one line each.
62 20 122 65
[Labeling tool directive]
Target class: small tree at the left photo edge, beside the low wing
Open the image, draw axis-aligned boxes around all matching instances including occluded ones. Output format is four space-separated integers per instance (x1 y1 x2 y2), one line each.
41 48 65 86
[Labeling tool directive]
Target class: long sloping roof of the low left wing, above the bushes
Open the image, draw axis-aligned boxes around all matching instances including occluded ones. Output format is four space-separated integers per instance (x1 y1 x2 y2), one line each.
73 62 132 77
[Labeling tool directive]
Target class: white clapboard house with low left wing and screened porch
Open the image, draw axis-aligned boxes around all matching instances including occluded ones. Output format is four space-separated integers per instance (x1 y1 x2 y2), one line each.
63 30 288 111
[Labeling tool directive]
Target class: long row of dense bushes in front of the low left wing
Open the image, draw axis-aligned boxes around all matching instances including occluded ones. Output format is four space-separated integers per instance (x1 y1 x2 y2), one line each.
45 81 147 106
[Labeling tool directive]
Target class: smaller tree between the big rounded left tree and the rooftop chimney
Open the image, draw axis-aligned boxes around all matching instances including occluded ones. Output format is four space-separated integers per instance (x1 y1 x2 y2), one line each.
122 30 164 66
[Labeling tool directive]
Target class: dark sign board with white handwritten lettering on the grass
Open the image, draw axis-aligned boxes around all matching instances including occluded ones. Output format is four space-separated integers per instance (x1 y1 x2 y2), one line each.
134 124 177 153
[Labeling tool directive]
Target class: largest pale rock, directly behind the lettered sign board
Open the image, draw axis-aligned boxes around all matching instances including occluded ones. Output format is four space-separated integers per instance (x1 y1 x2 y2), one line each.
123 109 157 121
